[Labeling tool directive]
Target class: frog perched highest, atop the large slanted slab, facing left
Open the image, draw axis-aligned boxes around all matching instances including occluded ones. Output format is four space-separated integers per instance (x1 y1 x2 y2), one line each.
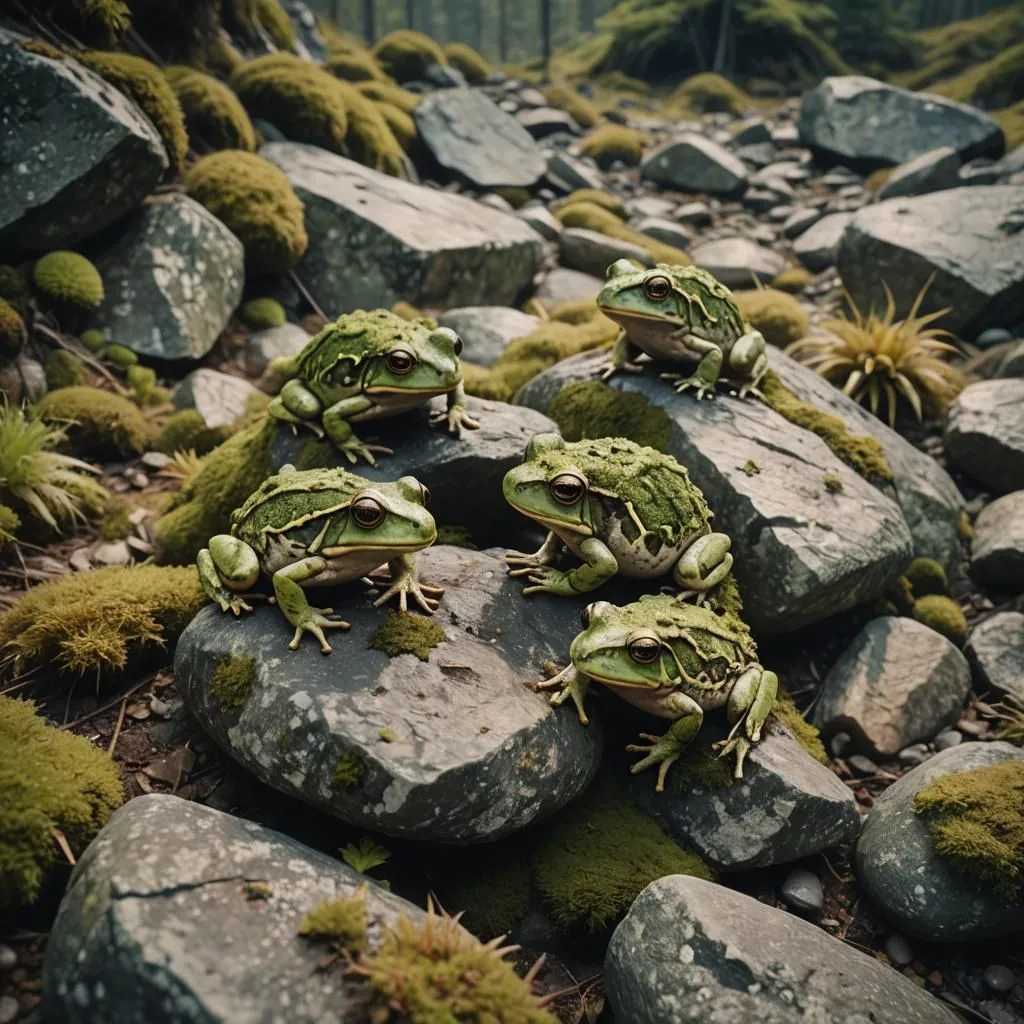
597 259 768 398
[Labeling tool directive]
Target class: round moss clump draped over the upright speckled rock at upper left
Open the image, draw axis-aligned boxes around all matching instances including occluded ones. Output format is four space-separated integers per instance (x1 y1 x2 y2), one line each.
185 150 309 273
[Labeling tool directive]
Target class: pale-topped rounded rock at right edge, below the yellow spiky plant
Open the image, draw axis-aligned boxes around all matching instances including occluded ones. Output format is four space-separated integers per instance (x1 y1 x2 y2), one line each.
945 385 1024 493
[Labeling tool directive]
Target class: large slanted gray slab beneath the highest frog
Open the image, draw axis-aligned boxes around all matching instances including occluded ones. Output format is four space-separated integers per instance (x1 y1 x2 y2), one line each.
517 352 912 633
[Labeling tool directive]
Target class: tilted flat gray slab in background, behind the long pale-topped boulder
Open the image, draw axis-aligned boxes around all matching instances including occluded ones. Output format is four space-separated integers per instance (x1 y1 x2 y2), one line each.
413 89 547 188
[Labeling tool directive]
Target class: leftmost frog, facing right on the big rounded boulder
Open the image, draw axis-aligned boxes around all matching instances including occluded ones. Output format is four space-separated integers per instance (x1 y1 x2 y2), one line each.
196 466 444 654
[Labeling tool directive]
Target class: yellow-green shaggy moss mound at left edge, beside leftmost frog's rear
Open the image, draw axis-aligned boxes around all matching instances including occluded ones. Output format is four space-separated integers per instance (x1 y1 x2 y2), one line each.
0 565 206 684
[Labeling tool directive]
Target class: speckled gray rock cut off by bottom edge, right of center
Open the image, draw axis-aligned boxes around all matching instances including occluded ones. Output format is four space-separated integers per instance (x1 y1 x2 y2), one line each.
604 874 961 1024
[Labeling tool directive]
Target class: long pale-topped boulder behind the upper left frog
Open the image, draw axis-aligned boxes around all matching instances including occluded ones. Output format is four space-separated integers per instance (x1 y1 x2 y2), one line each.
260 141 543 316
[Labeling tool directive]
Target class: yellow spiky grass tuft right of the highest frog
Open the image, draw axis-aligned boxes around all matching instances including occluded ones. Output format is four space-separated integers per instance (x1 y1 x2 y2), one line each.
785 280 964 426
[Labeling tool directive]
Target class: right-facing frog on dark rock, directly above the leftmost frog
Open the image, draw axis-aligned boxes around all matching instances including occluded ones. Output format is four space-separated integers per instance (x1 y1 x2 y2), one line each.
269 309 479 466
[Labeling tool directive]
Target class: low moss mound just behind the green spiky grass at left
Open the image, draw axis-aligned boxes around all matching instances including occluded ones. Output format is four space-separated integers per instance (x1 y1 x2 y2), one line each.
38 387 152 459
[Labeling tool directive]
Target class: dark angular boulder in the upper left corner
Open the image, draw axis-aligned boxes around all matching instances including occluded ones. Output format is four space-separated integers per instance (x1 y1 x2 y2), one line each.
0 28 168 252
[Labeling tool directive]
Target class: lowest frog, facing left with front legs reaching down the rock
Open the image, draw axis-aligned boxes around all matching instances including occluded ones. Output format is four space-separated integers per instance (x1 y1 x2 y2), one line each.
532 594 778 793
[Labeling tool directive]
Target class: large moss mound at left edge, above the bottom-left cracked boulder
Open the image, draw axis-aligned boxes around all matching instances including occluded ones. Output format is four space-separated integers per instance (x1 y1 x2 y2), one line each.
0 697 124 907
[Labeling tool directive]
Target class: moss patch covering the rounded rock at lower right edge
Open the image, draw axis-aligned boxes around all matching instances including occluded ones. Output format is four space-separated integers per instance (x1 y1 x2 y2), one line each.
913 761 1024 901
